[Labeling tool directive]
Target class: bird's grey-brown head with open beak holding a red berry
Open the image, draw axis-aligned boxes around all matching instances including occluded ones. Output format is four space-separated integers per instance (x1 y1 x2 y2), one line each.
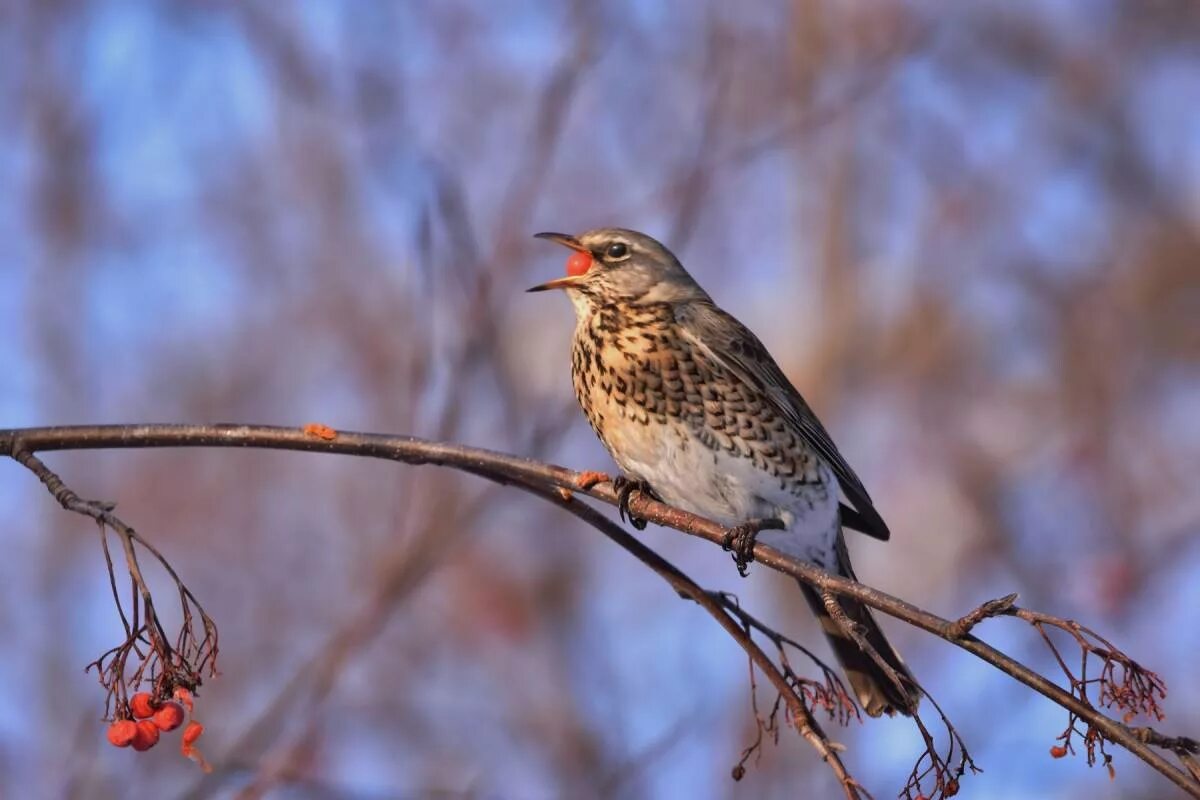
529 228 708 315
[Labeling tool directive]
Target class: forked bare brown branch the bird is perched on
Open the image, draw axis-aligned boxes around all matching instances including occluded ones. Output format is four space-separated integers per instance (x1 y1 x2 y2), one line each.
0 425 1200 798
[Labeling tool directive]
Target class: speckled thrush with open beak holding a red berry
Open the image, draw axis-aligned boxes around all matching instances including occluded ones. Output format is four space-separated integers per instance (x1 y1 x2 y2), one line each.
529 228 920 716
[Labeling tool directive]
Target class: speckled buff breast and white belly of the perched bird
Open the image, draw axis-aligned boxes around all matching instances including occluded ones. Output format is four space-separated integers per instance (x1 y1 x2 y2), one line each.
571 306 836 524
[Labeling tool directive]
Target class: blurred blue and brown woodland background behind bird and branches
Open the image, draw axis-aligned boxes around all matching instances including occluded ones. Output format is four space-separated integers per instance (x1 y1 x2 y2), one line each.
0 0 1200 800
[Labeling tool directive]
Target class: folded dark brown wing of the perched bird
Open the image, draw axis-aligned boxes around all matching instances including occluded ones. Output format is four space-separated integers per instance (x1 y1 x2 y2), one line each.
676 302 892 541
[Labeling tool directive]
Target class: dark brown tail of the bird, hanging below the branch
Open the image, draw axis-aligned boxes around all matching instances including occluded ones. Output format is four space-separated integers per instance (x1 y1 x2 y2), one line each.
800 535 920 717
